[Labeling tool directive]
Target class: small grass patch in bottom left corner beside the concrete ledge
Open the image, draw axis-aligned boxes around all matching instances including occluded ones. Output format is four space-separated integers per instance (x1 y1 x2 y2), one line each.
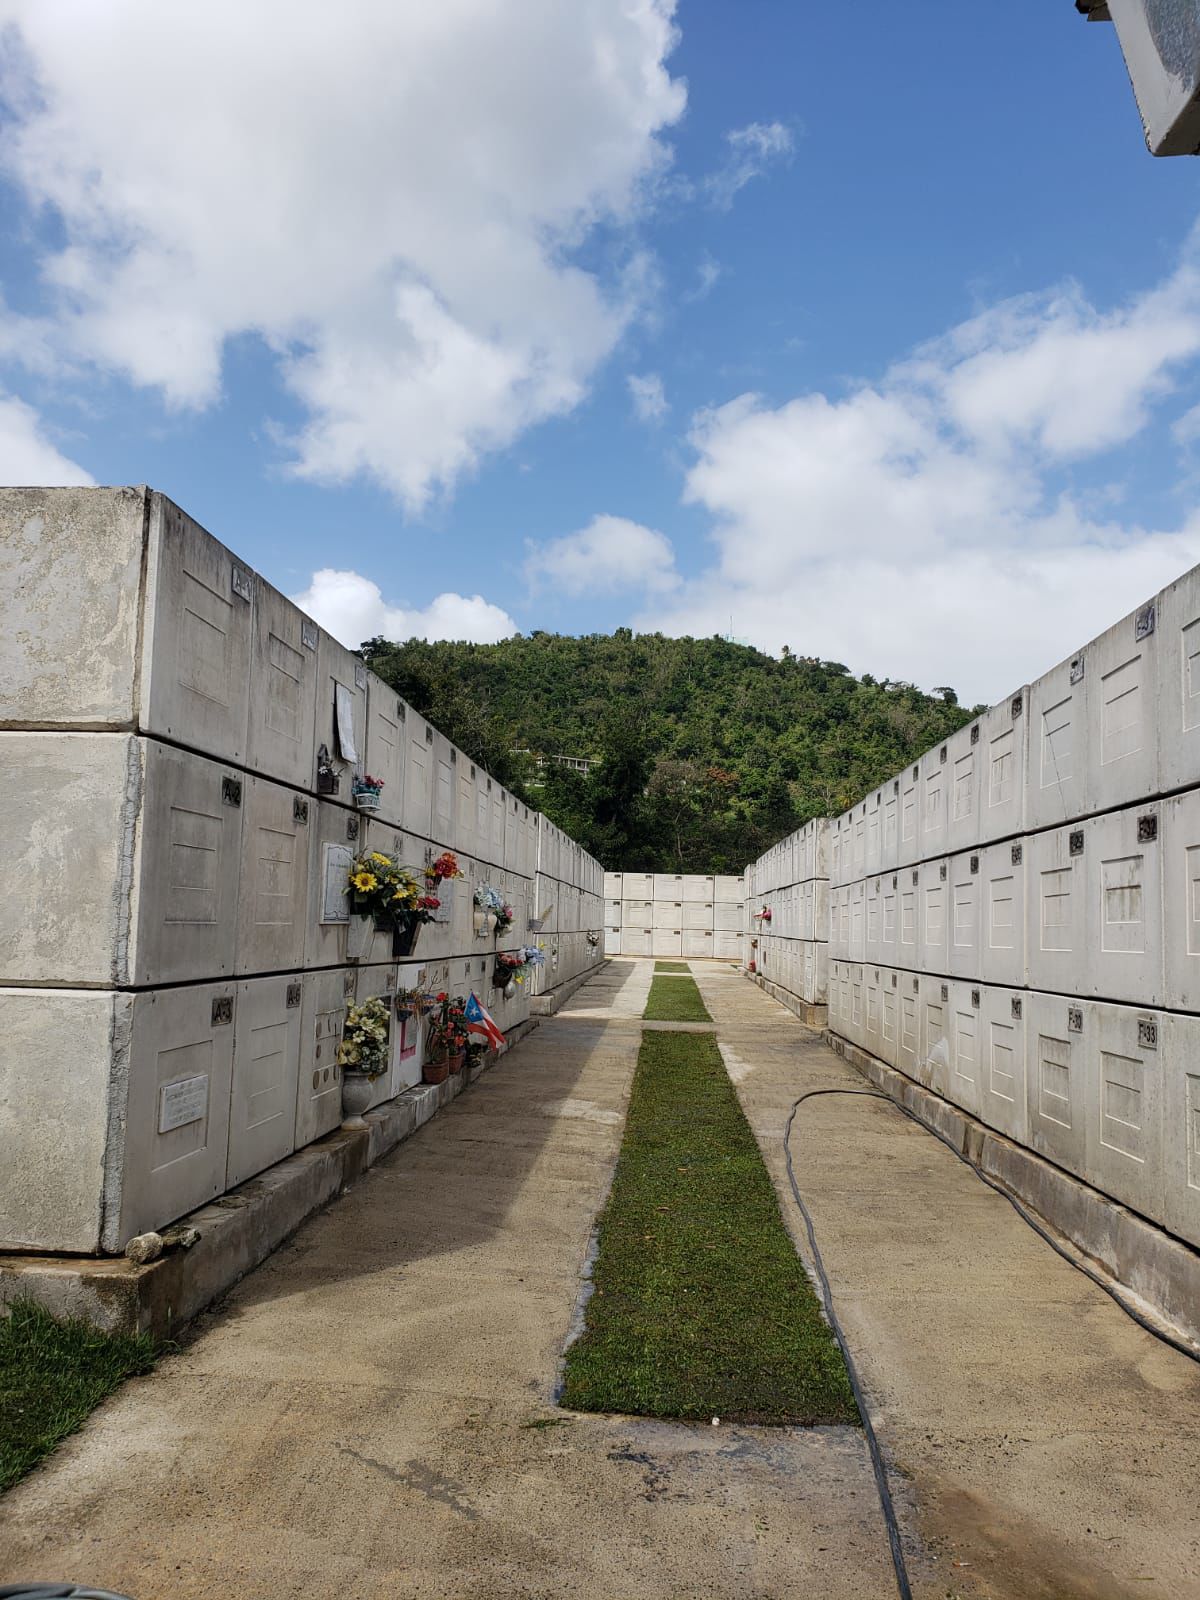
0 1301 155 1491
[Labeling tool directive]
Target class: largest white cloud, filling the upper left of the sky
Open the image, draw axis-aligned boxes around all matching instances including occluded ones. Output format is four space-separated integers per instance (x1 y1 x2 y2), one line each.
0 0 685 507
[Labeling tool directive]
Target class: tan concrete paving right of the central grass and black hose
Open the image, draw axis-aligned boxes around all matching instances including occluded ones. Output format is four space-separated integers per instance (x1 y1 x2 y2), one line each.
696 970 1200 1600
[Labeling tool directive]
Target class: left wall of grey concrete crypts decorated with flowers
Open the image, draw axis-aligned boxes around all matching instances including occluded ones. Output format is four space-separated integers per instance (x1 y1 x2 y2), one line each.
0 490 603 1251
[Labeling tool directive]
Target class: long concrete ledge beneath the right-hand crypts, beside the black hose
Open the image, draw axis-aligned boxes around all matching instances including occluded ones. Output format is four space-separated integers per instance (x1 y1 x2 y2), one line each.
826 1034 1200 1350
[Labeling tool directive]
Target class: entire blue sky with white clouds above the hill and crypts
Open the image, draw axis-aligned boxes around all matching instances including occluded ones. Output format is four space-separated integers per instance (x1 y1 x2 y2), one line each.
0 0 1200 699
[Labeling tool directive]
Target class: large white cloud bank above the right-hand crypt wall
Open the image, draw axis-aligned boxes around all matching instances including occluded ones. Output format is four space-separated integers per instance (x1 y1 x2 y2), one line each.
637 248 1200 701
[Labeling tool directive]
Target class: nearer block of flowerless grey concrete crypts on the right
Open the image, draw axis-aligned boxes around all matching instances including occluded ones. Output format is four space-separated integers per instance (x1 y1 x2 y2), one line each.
750 570 1200 1245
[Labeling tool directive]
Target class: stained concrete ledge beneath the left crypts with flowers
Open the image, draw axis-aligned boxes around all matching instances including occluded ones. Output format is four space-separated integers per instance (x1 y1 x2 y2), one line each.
0 1018 538 1339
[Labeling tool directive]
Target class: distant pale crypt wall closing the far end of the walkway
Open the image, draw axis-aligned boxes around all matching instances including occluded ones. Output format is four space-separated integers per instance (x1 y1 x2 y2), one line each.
603 872 746 962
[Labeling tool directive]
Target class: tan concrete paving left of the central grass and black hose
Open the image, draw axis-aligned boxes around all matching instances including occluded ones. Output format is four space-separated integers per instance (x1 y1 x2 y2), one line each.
0 962 891 1600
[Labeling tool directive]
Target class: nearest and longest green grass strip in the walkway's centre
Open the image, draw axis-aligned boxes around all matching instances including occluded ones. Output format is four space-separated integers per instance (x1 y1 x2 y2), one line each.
560 1034 858 1424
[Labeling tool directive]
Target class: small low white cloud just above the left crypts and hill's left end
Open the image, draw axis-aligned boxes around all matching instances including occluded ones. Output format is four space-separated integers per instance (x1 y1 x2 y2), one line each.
291 566 520 650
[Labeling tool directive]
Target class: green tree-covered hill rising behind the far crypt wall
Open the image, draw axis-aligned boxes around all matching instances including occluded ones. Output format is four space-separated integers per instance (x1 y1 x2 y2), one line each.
362 627 973 872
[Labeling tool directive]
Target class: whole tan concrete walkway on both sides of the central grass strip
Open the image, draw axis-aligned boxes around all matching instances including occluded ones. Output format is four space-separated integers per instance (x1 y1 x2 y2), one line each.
0 962 1200 1600
